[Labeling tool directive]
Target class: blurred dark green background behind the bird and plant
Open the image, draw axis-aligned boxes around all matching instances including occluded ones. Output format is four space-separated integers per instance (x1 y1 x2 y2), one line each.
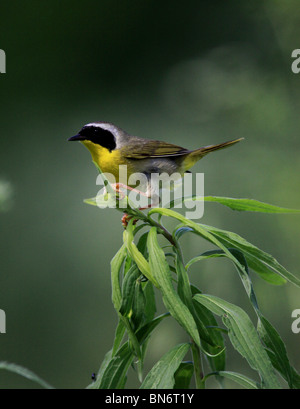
0 0 300 388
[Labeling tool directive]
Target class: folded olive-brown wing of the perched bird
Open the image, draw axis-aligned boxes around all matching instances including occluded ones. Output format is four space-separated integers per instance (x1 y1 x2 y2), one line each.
122 138 190 159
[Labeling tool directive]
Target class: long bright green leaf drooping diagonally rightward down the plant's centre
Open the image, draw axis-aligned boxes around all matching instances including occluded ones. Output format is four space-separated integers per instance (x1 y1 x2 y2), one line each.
147 227 200 347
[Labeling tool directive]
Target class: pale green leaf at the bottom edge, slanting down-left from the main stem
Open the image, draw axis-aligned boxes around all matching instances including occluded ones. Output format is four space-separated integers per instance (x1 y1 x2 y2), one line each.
140 344 190 389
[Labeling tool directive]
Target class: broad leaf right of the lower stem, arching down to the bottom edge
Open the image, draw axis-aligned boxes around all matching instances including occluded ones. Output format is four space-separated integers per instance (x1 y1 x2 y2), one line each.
194 294 281 389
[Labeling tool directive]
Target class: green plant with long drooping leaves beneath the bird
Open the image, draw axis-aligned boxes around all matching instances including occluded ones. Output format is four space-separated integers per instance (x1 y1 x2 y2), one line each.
86 173 300 389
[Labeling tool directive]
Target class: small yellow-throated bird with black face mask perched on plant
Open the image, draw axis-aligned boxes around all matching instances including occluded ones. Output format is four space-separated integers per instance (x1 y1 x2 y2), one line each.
68 122 243 207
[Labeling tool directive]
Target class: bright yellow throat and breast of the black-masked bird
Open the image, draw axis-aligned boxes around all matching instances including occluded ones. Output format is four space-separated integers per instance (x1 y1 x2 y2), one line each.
82 140 134 182
